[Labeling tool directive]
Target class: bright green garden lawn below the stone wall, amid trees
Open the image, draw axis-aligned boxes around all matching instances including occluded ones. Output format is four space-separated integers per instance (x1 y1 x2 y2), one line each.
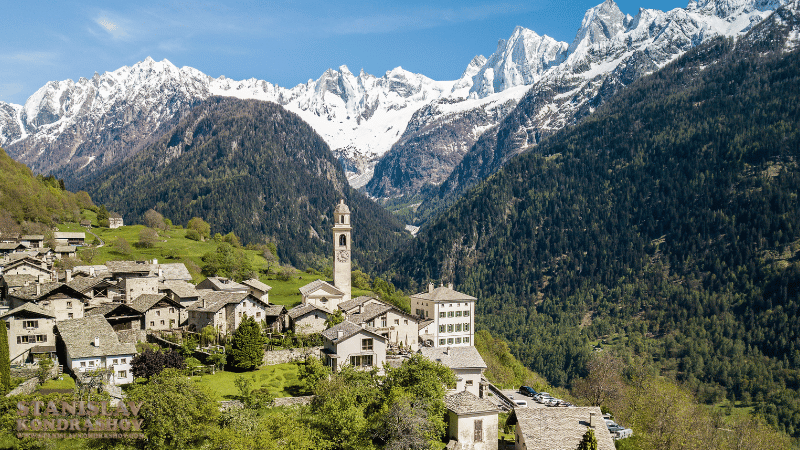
192 363 310 400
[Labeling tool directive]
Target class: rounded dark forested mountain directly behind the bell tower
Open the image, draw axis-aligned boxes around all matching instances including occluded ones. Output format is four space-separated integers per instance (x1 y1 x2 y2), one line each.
87 97 410 268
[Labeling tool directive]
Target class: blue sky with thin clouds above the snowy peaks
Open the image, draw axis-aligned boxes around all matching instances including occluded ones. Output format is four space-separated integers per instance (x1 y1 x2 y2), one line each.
0 0 688 103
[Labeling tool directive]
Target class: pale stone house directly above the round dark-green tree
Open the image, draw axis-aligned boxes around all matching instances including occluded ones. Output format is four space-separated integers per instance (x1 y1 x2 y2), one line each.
186 290 269 334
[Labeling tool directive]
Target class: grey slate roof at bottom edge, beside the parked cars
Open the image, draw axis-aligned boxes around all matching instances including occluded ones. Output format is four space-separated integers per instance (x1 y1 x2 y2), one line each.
507 406 615 450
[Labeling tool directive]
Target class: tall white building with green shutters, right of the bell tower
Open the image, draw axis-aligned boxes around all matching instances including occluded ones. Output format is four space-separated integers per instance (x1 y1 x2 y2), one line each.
410 283 476 347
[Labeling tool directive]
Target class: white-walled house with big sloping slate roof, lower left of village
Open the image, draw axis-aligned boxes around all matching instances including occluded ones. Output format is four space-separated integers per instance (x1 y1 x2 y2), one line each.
56 315 136 385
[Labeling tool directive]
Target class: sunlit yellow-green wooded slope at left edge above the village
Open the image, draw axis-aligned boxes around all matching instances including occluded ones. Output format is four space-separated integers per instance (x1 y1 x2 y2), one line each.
0 148 94 233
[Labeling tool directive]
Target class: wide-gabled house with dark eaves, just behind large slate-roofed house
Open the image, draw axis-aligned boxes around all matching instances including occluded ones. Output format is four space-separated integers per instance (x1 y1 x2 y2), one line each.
8 282 89 322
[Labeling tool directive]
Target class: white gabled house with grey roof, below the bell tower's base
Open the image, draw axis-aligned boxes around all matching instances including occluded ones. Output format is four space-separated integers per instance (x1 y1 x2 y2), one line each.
320 320 386 372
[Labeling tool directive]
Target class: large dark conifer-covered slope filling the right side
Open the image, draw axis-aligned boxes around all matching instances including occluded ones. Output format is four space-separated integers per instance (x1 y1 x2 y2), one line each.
386 4 800 436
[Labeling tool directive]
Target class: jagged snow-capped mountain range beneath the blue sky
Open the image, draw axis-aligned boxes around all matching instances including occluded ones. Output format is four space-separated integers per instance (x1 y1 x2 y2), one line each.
0 0 781 197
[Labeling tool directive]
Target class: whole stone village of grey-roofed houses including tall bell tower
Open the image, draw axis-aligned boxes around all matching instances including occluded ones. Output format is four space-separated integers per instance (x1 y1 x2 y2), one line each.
0 200 630 450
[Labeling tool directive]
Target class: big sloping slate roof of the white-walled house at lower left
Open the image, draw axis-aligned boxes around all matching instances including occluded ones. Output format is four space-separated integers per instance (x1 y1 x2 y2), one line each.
56 316 136 359
